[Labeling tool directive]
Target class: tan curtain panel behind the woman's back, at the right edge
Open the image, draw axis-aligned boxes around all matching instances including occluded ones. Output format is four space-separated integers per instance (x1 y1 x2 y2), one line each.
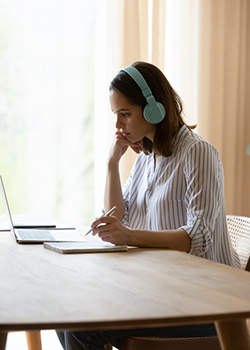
197 0 250 216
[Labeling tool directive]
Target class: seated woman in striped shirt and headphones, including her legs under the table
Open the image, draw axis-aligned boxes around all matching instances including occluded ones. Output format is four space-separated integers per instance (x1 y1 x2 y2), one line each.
58 62 240 350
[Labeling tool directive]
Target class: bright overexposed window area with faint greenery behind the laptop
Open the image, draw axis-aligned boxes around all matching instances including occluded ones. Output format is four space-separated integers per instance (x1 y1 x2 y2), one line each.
0 0 96 224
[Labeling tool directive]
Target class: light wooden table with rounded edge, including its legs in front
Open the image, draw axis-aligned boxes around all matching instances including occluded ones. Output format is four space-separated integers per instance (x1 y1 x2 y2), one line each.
0 226 250 350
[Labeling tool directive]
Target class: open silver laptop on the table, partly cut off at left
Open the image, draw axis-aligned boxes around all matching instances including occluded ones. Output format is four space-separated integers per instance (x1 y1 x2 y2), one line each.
0 175 85 244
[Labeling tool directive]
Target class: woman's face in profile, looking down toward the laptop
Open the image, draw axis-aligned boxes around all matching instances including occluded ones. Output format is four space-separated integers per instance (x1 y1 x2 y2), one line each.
109 90 156 143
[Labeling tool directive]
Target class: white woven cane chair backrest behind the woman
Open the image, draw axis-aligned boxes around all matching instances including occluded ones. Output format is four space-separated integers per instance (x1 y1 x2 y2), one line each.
227 215 250 270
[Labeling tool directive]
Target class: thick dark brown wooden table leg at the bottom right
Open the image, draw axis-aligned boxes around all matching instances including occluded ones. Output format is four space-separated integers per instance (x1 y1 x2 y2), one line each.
215 319 250 350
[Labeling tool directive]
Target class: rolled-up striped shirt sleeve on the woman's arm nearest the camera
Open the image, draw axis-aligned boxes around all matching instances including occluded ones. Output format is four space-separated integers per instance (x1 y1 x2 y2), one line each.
181 141 224 255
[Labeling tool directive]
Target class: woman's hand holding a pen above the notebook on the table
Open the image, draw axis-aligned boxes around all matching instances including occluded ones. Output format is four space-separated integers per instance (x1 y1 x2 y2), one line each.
91 216 131 245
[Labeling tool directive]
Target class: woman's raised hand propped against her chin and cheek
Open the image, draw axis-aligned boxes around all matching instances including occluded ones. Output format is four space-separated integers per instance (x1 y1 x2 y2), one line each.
109 129 142 163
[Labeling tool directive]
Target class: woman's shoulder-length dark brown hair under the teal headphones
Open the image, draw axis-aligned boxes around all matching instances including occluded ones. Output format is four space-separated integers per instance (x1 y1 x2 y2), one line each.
110 62 195 157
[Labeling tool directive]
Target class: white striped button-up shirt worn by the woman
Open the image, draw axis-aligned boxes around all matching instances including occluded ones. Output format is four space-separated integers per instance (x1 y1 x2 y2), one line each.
122 125 240 267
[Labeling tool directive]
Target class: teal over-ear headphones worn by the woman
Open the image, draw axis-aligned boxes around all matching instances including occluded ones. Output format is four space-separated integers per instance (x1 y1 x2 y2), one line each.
121 66 166 124
